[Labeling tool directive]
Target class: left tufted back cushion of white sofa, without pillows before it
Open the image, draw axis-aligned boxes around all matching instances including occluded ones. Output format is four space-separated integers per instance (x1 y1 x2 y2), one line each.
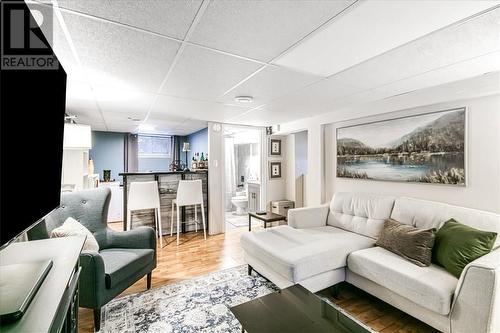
327 192 396 239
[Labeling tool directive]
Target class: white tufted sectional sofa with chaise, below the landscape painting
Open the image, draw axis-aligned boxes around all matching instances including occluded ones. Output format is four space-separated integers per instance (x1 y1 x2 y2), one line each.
241 193 500 333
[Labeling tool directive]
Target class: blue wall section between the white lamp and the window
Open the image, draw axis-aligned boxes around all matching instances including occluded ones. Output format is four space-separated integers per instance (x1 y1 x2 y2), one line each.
90 131 126 182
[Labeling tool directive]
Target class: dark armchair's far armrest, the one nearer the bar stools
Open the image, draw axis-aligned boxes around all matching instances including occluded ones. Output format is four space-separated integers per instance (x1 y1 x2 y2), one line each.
108 227 156 250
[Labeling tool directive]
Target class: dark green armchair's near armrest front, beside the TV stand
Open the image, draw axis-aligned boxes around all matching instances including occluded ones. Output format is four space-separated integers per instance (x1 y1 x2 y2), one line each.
79 251 106 309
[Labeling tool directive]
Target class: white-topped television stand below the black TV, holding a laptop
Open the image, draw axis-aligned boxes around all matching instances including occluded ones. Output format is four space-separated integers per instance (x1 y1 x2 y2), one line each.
0 236 85 333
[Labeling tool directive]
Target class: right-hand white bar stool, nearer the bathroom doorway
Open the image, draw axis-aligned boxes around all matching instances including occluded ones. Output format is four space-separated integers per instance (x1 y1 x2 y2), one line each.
170 179 207 245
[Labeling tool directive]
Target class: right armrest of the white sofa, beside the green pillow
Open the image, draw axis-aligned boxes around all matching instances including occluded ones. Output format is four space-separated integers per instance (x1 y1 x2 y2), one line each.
450 249 500 333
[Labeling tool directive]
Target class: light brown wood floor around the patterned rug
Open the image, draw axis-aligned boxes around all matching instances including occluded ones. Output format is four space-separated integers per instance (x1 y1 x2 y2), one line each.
79 223 437 333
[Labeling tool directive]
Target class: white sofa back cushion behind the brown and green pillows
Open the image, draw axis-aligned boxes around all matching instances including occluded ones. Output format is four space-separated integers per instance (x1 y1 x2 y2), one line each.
391 197 500 248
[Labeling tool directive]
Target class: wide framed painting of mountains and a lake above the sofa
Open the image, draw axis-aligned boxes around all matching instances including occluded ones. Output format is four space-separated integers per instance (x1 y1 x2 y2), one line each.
337 108 466 186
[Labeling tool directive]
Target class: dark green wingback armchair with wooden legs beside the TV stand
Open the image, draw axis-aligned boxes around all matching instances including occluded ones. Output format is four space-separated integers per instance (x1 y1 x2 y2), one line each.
28 188 156 331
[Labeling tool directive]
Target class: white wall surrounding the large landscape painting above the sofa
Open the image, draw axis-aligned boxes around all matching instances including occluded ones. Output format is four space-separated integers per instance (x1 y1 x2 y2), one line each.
279 75 500 213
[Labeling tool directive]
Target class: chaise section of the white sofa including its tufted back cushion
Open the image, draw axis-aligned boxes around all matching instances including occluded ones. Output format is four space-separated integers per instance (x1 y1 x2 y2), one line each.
241 193 395 292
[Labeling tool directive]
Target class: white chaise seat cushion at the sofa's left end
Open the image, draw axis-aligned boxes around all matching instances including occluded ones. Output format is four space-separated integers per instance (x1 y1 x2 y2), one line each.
241 225 375 282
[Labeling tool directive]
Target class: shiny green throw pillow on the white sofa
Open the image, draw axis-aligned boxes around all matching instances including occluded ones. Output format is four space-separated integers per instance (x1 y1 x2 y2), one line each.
432 219 497 278
